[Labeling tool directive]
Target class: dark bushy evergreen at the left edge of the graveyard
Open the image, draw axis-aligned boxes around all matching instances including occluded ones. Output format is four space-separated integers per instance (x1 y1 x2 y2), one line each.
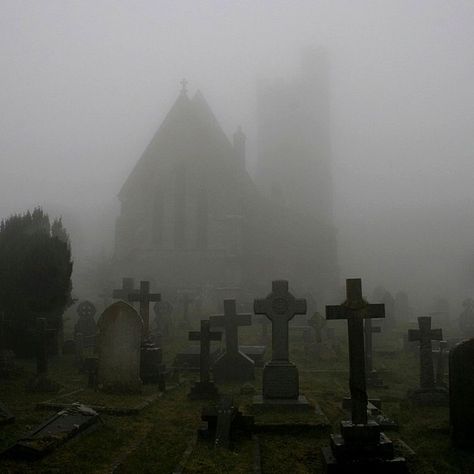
0 208 73 355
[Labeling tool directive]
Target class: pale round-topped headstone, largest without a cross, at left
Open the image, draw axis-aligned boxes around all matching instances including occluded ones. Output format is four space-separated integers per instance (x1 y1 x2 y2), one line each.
97 301 143 393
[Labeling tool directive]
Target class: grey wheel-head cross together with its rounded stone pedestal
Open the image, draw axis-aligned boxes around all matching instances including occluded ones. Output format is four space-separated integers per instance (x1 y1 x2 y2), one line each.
254 280 309 408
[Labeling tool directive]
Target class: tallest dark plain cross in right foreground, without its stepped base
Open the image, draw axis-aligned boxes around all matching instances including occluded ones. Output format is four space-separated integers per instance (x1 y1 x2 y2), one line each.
326 278 385 425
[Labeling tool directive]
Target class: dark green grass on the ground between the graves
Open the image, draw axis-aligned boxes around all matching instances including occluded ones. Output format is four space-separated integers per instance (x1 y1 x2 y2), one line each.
0 324 474 474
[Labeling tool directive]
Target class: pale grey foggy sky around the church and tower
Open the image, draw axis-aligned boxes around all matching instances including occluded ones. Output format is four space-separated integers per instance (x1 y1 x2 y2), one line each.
0 0 474 312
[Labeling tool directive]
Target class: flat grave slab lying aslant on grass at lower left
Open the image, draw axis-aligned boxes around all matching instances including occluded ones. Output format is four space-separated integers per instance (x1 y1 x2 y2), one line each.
2 403 99 459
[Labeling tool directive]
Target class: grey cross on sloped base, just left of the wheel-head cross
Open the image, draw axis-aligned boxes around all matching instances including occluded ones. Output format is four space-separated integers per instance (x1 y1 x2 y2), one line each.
209 299 255 382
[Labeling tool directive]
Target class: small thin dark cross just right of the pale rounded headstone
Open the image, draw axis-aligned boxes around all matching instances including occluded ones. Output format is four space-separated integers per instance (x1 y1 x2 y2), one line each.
188 320 222 400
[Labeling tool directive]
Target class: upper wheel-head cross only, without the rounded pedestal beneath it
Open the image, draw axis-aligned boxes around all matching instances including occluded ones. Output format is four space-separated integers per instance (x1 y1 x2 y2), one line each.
253 280 306 362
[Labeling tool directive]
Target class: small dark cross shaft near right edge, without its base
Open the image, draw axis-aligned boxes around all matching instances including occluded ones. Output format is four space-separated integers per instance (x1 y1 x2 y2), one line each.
408 316 443 389
